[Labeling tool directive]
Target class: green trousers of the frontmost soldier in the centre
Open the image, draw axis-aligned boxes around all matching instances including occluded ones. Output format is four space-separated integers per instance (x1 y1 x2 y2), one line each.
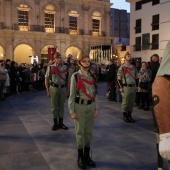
74 102 95 149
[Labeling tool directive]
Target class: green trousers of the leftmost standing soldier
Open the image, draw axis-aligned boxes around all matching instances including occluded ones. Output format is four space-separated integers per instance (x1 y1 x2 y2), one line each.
49 86 66 118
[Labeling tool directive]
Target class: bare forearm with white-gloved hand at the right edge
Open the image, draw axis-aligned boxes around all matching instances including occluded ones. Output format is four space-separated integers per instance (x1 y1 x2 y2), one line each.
152 76 170 160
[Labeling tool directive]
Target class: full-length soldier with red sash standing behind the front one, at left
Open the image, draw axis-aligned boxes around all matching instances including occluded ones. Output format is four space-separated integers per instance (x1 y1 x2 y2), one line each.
45 52 70 130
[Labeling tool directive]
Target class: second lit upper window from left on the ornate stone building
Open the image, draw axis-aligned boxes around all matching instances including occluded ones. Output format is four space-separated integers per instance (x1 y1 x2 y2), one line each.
45 13 54 33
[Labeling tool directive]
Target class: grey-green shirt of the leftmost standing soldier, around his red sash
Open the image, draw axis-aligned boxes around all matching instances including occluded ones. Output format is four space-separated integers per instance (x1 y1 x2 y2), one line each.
45 63 71 85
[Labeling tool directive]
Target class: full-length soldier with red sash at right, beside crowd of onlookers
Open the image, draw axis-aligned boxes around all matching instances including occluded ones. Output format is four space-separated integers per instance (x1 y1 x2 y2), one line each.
117 52 138 123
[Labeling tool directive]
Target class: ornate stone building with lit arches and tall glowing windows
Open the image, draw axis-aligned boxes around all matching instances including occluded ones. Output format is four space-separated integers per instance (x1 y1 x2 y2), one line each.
0 0 112 63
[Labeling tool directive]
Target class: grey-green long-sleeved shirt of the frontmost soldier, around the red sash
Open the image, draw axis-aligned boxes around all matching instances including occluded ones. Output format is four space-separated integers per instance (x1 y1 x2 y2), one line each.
68 70 98 114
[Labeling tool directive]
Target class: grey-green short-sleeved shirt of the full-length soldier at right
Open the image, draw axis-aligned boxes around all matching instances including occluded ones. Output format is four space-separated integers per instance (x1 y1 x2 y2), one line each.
117 64 138 84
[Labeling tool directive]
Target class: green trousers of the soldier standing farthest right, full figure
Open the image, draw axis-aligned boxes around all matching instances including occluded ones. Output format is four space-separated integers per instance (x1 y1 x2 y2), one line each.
122 86 136 112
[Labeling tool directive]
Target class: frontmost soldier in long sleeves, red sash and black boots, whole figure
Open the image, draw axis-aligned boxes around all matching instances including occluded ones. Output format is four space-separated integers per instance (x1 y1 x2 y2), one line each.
68 54 98 169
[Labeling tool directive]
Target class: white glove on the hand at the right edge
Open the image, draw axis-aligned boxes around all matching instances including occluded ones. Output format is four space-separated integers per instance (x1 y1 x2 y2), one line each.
159 133 170 160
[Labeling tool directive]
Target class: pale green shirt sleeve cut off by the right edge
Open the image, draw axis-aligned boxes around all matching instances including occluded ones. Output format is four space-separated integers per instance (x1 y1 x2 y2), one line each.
157 41 170 76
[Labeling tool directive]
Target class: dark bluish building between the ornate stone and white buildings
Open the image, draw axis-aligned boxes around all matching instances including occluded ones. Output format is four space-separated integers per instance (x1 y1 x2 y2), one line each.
110 8 130 59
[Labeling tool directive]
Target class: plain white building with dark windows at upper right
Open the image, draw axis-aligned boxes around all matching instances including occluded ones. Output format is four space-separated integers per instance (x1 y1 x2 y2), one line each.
126 0 170 61
